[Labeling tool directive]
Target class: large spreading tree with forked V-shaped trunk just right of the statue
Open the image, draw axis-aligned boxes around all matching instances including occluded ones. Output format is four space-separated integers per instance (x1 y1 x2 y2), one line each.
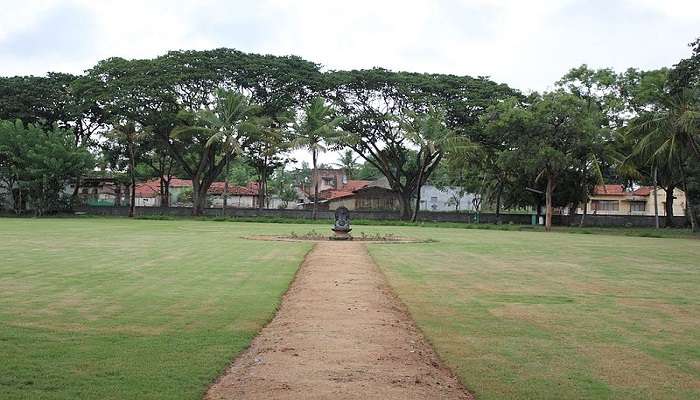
326 68 514 219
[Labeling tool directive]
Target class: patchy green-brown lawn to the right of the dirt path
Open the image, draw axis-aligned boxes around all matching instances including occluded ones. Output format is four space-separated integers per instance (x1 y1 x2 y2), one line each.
370 228 700 399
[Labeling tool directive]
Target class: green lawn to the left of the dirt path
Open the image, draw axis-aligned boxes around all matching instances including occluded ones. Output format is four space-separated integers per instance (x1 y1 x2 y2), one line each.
0 219 310 400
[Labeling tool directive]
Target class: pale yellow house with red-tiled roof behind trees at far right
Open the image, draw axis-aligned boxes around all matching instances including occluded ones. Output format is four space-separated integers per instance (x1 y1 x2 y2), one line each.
576 185 686 216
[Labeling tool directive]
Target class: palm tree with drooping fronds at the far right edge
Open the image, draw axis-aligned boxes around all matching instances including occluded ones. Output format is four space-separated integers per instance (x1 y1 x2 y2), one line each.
629 88 700 231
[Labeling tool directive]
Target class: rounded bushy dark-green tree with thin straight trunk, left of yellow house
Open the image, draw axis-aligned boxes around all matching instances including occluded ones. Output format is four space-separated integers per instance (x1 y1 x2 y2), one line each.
486 91 601 231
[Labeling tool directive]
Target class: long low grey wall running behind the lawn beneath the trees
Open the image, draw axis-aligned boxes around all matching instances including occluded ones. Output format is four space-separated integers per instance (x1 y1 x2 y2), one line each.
75 206 687 227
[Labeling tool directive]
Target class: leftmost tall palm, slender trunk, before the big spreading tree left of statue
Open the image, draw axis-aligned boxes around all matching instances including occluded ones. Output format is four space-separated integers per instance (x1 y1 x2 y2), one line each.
172 89 260 216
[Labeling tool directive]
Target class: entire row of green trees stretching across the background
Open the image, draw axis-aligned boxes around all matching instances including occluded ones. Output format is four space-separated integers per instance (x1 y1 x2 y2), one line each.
0 42 700 228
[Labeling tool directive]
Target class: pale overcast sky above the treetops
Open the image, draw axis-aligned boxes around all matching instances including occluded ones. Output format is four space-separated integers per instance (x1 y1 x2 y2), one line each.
0 0 700 166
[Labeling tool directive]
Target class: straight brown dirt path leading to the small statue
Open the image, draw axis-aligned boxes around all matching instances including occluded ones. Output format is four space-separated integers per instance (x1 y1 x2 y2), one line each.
205 242 471 399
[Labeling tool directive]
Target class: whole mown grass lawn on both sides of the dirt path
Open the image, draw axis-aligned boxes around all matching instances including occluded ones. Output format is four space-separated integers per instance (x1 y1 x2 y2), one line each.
0 218 700 399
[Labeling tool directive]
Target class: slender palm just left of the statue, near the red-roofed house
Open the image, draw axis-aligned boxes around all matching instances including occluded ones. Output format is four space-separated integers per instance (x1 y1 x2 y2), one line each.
292 97 343 219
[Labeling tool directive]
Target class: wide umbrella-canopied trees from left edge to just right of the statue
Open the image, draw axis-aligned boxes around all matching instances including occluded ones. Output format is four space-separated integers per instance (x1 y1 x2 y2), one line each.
0 49 517 217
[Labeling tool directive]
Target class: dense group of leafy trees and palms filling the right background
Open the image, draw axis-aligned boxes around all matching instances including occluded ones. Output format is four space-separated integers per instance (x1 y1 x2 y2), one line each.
441 41 700 229
